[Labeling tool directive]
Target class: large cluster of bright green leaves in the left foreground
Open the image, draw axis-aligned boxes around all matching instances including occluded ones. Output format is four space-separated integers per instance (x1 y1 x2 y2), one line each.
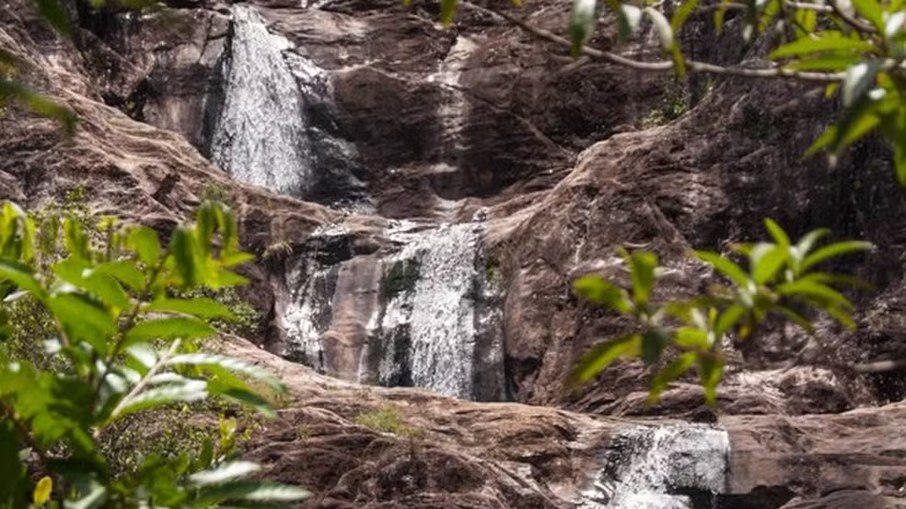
0 202 305 508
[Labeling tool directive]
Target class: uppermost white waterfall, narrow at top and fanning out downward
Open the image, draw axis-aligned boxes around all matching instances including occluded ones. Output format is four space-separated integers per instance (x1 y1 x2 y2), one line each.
209 5 311 195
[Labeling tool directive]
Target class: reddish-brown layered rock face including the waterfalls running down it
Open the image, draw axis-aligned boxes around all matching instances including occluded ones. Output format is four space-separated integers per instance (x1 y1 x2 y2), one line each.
0 0 906 509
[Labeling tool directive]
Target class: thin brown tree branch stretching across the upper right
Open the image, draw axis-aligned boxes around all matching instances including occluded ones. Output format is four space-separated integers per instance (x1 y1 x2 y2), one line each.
460 0 844 83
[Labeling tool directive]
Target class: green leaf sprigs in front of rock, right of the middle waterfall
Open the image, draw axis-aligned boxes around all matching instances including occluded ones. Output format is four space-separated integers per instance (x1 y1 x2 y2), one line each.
575 219 872 405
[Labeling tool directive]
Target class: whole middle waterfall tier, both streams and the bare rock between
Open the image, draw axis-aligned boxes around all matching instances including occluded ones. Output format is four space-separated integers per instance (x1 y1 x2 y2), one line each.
281 216 504 400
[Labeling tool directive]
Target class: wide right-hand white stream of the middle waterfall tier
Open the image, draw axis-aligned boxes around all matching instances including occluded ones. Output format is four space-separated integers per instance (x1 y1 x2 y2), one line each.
380 221 484 398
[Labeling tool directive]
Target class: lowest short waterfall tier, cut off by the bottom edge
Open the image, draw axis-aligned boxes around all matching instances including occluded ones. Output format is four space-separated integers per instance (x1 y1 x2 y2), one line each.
578 424 730 509
